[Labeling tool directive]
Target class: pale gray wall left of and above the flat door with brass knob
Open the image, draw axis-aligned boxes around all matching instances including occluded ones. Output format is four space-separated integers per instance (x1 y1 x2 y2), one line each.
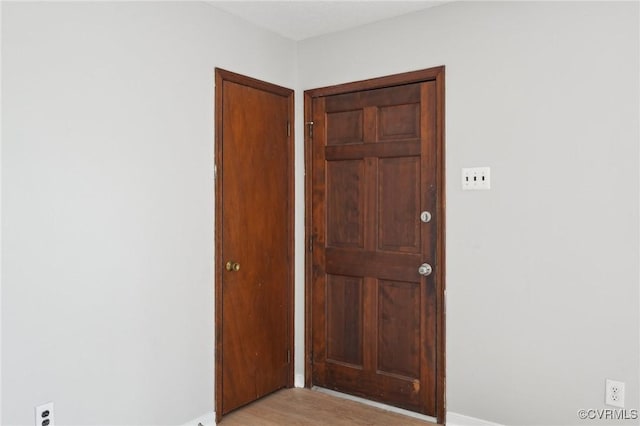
0 2 295 425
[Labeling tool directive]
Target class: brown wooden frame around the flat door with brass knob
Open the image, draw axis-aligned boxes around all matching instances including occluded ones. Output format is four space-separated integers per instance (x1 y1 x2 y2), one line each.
214 68 295 422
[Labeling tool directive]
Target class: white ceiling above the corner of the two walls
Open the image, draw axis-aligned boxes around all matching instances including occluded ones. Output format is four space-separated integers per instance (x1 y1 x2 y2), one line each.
207 0 450 41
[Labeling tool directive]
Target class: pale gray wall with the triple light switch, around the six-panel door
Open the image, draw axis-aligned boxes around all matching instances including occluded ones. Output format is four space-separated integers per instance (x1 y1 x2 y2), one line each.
298 2 640 425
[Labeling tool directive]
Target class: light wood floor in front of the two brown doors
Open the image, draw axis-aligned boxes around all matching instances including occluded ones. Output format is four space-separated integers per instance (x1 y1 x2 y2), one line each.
219 389 434 426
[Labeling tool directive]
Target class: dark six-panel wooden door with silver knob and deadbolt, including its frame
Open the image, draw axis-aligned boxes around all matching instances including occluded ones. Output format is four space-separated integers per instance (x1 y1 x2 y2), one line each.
307 68 444 420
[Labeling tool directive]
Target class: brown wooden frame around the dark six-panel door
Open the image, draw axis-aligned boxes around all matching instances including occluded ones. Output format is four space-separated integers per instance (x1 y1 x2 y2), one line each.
304 66 446 424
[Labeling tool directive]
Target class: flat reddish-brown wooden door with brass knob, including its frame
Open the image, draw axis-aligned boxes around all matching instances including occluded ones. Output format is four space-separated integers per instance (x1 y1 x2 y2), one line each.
215 70 293 417
